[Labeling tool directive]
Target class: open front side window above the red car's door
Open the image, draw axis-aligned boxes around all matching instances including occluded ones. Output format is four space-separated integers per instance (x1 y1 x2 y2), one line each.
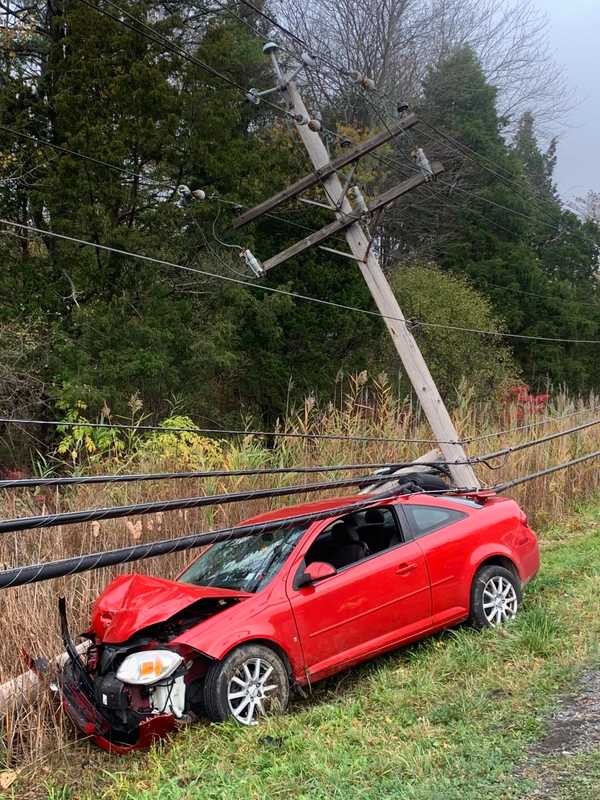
305 507 404 570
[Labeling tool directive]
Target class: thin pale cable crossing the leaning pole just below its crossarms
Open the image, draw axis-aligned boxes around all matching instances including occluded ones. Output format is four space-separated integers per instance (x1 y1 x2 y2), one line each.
0 218 600 344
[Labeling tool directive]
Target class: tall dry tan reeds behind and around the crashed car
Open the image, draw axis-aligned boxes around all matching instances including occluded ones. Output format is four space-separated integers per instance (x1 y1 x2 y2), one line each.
0 376 600 764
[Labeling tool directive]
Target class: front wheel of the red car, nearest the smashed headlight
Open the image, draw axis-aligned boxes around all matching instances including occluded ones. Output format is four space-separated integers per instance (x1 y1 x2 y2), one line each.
204 644 290 725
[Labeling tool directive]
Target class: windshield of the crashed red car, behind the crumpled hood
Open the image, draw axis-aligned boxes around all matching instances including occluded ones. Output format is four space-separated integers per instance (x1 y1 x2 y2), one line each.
179 525 308 592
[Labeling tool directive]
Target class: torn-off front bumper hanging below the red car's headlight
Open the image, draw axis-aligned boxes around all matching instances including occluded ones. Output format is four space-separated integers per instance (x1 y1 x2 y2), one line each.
59 598 177 754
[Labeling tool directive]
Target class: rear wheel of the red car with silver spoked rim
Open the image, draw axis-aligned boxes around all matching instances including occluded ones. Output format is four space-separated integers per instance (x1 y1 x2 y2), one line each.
469 564 523 629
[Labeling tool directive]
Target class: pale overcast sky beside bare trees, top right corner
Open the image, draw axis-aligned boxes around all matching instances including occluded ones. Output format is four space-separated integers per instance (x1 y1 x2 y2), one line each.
536 0 600 200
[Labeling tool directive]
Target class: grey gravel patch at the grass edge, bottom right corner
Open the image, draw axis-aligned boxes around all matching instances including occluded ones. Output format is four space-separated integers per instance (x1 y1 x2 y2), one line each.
522 670 600 800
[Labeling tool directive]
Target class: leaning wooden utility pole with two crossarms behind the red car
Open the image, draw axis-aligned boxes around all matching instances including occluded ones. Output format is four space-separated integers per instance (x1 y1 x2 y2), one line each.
234 42 479 489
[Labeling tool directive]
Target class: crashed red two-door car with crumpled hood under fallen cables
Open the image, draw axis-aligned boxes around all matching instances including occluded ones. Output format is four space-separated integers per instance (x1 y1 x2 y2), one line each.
60 484 539 752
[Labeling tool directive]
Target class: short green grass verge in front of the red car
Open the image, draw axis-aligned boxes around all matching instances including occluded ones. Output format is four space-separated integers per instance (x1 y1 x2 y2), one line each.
13 504 600 800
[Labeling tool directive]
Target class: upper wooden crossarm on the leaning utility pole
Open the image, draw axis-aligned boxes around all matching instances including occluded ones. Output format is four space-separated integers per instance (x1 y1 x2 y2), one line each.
232 114 419 228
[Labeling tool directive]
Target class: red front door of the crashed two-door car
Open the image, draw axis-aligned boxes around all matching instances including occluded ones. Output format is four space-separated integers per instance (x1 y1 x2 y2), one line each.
287 509 431 679
